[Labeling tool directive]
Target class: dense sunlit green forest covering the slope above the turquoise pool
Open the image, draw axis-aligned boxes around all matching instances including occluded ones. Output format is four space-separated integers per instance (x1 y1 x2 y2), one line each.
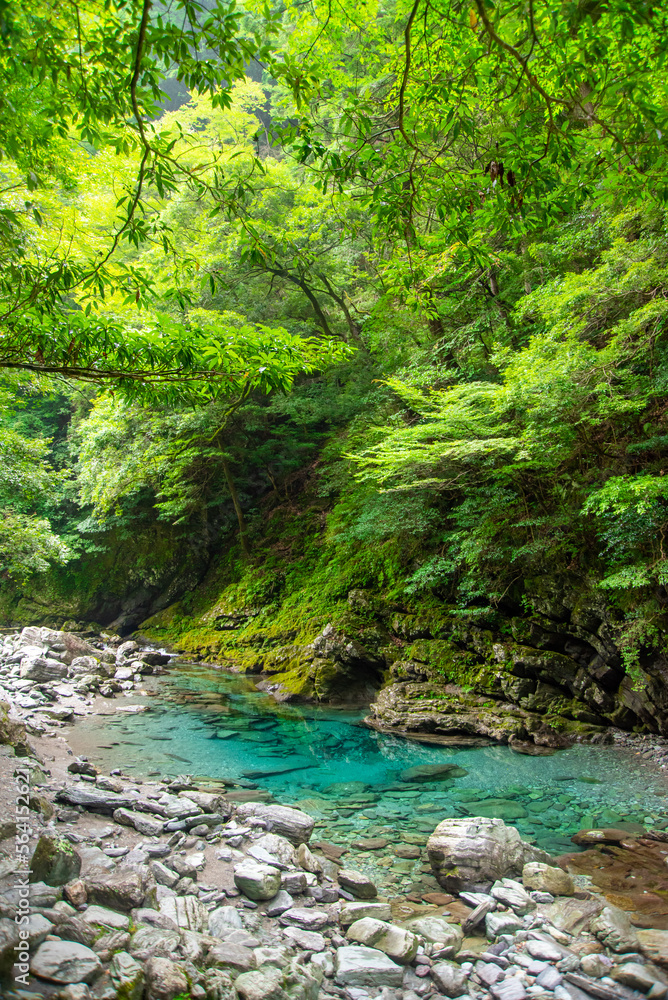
0 0 668 729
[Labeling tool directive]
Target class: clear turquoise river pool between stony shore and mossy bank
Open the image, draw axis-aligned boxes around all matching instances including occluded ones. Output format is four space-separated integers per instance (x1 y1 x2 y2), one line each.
69 663 668 878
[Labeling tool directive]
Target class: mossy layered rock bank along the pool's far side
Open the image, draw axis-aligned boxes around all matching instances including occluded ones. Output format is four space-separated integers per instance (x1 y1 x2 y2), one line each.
141 574 668 747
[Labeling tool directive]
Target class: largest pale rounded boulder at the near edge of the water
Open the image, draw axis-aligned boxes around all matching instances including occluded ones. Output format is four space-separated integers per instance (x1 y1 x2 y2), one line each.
427 818 549 892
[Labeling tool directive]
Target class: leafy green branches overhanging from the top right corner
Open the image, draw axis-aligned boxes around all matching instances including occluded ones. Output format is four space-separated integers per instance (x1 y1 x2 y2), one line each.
284 0 668 328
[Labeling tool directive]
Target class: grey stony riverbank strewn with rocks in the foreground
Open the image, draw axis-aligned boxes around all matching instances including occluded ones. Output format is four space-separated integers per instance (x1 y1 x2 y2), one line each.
0 629 668 1000
